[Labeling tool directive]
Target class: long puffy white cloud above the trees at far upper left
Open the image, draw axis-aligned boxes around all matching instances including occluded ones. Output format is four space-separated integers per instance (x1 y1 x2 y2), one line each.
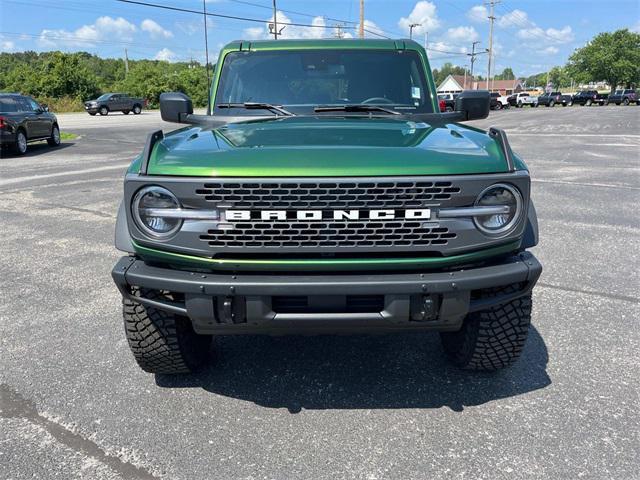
38 16 136 47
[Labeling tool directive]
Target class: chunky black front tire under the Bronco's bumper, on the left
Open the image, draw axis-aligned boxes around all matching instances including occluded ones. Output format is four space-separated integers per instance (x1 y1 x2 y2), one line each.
122 290 211 374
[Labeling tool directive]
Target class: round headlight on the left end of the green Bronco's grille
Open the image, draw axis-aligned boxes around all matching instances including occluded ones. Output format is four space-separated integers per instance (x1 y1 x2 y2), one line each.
131 186 182 238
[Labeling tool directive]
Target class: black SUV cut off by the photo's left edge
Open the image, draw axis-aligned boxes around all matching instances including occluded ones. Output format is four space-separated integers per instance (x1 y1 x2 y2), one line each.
0 93 60 155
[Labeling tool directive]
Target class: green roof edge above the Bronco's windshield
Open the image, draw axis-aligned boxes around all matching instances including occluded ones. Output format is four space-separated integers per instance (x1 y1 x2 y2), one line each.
223 38 422 51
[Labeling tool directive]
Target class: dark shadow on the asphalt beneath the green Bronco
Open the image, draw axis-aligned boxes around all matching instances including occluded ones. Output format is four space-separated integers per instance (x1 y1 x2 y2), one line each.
156 327 551 413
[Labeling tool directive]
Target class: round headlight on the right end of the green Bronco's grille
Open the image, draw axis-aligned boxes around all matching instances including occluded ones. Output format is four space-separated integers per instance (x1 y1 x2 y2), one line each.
474 183 522 235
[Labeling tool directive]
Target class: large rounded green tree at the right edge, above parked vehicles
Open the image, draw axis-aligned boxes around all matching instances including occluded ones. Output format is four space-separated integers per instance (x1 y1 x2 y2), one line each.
567 28 640 90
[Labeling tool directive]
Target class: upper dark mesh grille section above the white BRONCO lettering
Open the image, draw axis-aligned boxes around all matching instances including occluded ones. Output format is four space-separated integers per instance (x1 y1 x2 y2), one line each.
196 181 460 210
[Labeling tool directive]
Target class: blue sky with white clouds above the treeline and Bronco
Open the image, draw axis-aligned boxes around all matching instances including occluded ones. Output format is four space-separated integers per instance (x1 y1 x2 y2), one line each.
0 0 640 76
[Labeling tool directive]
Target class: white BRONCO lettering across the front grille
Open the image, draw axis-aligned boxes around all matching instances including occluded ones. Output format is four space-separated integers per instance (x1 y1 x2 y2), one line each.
223 208 431 222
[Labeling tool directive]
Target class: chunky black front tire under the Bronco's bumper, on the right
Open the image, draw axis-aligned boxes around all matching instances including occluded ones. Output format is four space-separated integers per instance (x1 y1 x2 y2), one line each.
440 288 531 371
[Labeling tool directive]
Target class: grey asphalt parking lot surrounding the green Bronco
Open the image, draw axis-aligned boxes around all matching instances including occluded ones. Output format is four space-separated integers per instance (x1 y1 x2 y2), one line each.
0 106 640 480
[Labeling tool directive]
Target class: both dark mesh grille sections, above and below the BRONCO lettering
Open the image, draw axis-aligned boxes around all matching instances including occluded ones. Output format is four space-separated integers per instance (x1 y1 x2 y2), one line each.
196 181 460 250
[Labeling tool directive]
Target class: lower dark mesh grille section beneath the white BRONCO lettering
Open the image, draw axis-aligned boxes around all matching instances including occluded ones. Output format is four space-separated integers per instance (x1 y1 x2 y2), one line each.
200 220 456 248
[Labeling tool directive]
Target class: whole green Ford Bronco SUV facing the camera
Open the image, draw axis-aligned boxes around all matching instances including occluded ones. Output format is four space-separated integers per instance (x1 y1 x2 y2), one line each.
113 40 542 373
